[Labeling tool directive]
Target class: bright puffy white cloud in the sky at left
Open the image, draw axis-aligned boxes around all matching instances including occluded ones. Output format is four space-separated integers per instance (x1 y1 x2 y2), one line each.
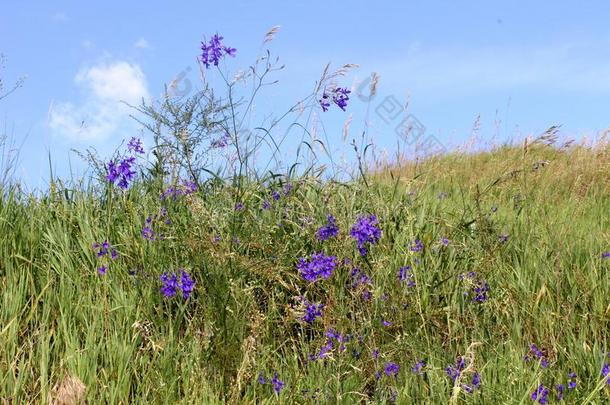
48 61 150 142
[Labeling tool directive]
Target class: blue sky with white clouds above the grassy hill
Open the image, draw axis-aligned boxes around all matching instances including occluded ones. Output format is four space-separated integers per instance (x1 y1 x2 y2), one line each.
0 0 610 187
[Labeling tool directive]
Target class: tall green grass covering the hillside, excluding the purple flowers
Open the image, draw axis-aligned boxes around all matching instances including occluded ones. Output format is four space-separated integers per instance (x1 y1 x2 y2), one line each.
0 141 610 404
